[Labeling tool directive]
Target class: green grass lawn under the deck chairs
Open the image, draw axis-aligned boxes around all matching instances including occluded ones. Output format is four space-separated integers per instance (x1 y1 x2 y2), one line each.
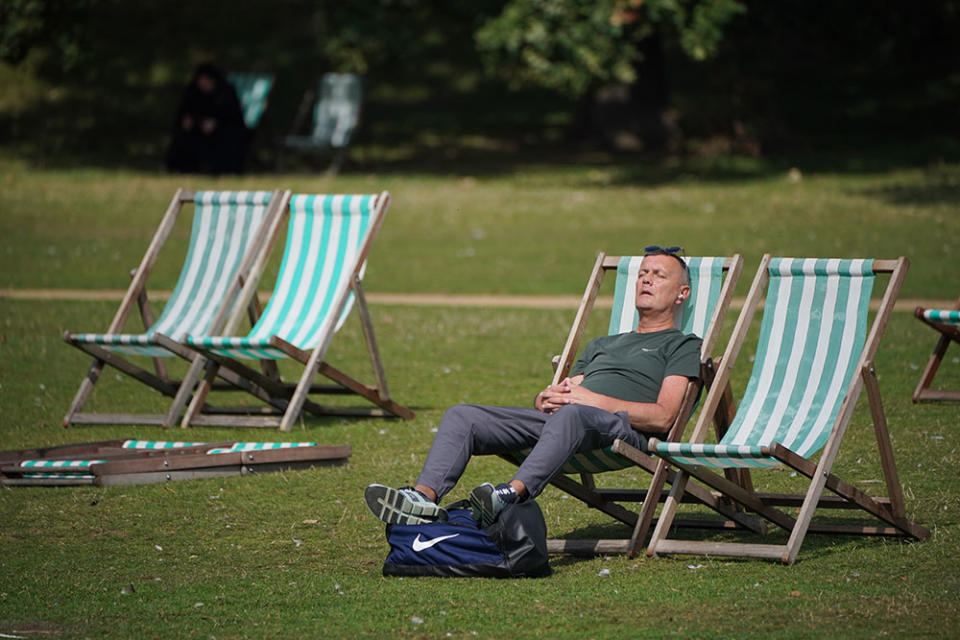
0 159 960 638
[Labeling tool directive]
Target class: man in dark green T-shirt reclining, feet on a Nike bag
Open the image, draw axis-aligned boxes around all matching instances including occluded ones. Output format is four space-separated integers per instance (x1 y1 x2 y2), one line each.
365 247 701 527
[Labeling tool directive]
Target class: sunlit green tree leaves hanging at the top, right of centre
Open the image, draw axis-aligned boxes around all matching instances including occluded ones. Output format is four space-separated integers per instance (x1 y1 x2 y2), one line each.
476 0 745 95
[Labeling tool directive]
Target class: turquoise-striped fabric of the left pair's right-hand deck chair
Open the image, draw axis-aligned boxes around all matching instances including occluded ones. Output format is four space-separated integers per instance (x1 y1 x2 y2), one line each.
186 195 376 359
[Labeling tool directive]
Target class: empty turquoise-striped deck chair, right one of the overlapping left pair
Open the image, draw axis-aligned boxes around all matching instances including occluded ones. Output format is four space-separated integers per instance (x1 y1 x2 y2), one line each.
169 191 413 431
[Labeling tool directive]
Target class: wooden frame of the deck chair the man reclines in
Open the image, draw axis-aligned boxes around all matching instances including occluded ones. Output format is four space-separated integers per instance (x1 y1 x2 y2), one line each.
501 253 763 557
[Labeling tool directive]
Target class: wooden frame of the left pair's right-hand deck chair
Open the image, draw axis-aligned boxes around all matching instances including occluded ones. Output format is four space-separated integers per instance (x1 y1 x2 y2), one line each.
167 191 414 431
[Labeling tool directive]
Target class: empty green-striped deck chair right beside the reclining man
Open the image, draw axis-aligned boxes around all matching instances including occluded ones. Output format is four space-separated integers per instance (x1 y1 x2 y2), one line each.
647 255 930 564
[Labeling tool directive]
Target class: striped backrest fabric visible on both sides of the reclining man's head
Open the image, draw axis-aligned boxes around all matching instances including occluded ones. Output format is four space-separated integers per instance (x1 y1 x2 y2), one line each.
609 256 724 338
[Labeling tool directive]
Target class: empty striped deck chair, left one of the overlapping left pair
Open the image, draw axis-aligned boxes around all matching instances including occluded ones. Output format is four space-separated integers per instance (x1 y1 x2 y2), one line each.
63 189 289 426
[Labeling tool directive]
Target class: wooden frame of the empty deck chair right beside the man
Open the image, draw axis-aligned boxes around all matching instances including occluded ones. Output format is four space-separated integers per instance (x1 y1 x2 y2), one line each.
647 254 930 564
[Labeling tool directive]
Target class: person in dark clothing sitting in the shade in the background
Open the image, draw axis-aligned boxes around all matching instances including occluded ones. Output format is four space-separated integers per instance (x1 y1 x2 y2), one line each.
167 63 249 174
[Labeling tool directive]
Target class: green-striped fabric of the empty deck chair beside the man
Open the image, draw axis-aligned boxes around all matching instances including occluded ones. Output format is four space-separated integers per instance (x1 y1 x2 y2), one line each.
655 258 874 469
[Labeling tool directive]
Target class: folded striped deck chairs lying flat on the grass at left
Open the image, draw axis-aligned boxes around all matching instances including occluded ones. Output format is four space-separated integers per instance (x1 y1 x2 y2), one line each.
0 440 351 486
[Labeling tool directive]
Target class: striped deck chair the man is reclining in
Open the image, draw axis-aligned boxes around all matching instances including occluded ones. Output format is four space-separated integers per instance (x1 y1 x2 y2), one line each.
501 253 759 556
